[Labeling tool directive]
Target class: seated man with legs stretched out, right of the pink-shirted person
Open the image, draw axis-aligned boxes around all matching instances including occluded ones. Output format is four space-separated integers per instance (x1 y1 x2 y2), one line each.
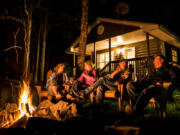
78 60 131 106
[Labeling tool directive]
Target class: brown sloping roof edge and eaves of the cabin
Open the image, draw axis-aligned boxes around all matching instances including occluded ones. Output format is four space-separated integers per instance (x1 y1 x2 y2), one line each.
66 18 180 54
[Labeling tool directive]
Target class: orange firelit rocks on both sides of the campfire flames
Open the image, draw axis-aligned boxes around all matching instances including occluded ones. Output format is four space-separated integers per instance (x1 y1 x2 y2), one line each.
0 100 78 128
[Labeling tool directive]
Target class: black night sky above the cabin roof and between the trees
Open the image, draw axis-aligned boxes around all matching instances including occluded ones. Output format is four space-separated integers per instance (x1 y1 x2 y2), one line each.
0 0 180 78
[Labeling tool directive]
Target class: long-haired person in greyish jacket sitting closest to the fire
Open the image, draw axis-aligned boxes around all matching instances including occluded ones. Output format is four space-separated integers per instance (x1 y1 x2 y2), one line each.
46 63 69 100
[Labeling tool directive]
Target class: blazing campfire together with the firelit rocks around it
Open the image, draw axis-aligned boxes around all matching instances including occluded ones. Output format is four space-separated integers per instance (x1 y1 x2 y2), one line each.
0 81 78 128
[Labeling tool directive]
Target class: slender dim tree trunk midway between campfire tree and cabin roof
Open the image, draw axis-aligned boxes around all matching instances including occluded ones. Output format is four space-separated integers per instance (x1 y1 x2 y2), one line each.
40 11 48 82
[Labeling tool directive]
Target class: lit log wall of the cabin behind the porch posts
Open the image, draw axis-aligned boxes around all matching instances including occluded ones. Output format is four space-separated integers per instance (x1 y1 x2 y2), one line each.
97 38 165 70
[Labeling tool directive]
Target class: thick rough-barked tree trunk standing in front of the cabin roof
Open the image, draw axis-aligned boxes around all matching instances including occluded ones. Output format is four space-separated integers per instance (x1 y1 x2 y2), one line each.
77 0 88 70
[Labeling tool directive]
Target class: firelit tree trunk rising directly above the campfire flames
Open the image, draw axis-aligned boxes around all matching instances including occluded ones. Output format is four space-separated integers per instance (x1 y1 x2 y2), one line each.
23 12 32 81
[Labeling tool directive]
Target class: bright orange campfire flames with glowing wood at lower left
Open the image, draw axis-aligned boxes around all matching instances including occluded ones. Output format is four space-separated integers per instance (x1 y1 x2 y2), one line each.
0 81 35 128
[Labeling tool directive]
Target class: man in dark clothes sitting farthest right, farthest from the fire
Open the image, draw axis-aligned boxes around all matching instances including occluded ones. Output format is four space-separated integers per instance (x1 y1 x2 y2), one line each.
126 55 176 114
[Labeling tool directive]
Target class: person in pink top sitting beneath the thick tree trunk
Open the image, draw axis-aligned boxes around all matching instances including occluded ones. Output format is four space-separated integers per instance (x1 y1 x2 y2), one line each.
67 61 97 100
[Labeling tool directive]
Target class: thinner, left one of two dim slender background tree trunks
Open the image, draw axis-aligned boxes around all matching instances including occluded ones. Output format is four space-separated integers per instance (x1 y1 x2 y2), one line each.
34 19 42 83
